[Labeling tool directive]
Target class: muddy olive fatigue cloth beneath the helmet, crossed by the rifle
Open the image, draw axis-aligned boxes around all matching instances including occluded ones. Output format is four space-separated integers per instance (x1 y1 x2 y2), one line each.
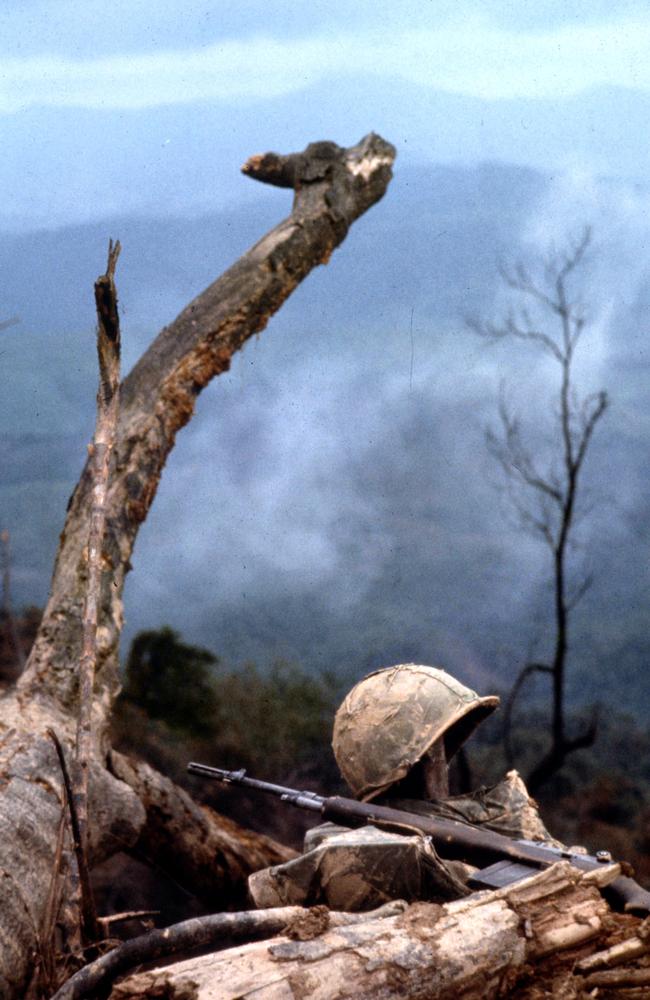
248 771 563 911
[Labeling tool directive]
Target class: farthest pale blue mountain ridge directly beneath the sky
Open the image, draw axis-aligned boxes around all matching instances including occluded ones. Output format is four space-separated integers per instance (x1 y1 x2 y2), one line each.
0 80 650 231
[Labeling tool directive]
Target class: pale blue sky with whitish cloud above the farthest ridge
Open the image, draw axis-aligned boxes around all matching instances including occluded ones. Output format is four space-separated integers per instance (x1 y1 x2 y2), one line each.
0 0 650 113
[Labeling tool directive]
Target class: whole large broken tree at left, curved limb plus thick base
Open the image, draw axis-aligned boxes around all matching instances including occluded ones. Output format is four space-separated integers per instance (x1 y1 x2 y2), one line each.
0 134 395 1000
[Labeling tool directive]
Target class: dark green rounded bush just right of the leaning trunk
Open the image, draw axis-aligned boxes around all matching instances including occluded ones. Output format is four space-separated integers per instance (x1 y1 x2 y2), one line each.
117 626 217 736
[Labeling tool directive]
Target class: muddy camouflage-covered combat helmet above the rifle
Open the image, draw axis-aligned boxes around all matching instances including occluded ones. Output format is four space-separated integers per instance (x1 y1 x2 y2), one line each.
332 663 499 801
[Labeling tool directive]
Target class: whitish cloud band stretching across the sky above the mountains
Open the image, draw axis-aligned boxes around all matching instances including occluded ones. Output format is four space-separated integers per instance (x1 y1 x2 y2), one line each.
0 17 650 112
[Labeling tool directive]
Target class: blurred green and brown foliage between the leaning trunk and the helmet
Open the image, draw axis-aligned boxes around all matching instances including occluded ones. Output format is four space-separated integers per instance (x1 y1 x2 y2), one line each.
113 627 340 780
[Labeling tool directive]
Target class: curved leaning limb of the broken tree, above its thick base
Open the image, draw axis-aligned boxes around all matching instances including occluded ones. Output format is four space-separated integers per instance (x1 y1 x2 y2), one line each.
21 134 395 728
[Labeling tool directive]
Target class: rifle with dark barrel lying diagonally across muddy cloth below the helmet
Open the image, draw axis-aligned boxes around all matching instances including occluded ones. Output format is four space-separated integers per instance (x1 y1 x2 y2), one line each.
187 763 650 916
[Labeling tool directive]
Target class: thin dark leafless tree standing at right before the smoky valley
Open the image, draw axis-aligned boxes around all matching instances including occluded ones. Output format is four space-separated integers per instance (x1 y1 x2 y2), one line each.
470 227 608 793
